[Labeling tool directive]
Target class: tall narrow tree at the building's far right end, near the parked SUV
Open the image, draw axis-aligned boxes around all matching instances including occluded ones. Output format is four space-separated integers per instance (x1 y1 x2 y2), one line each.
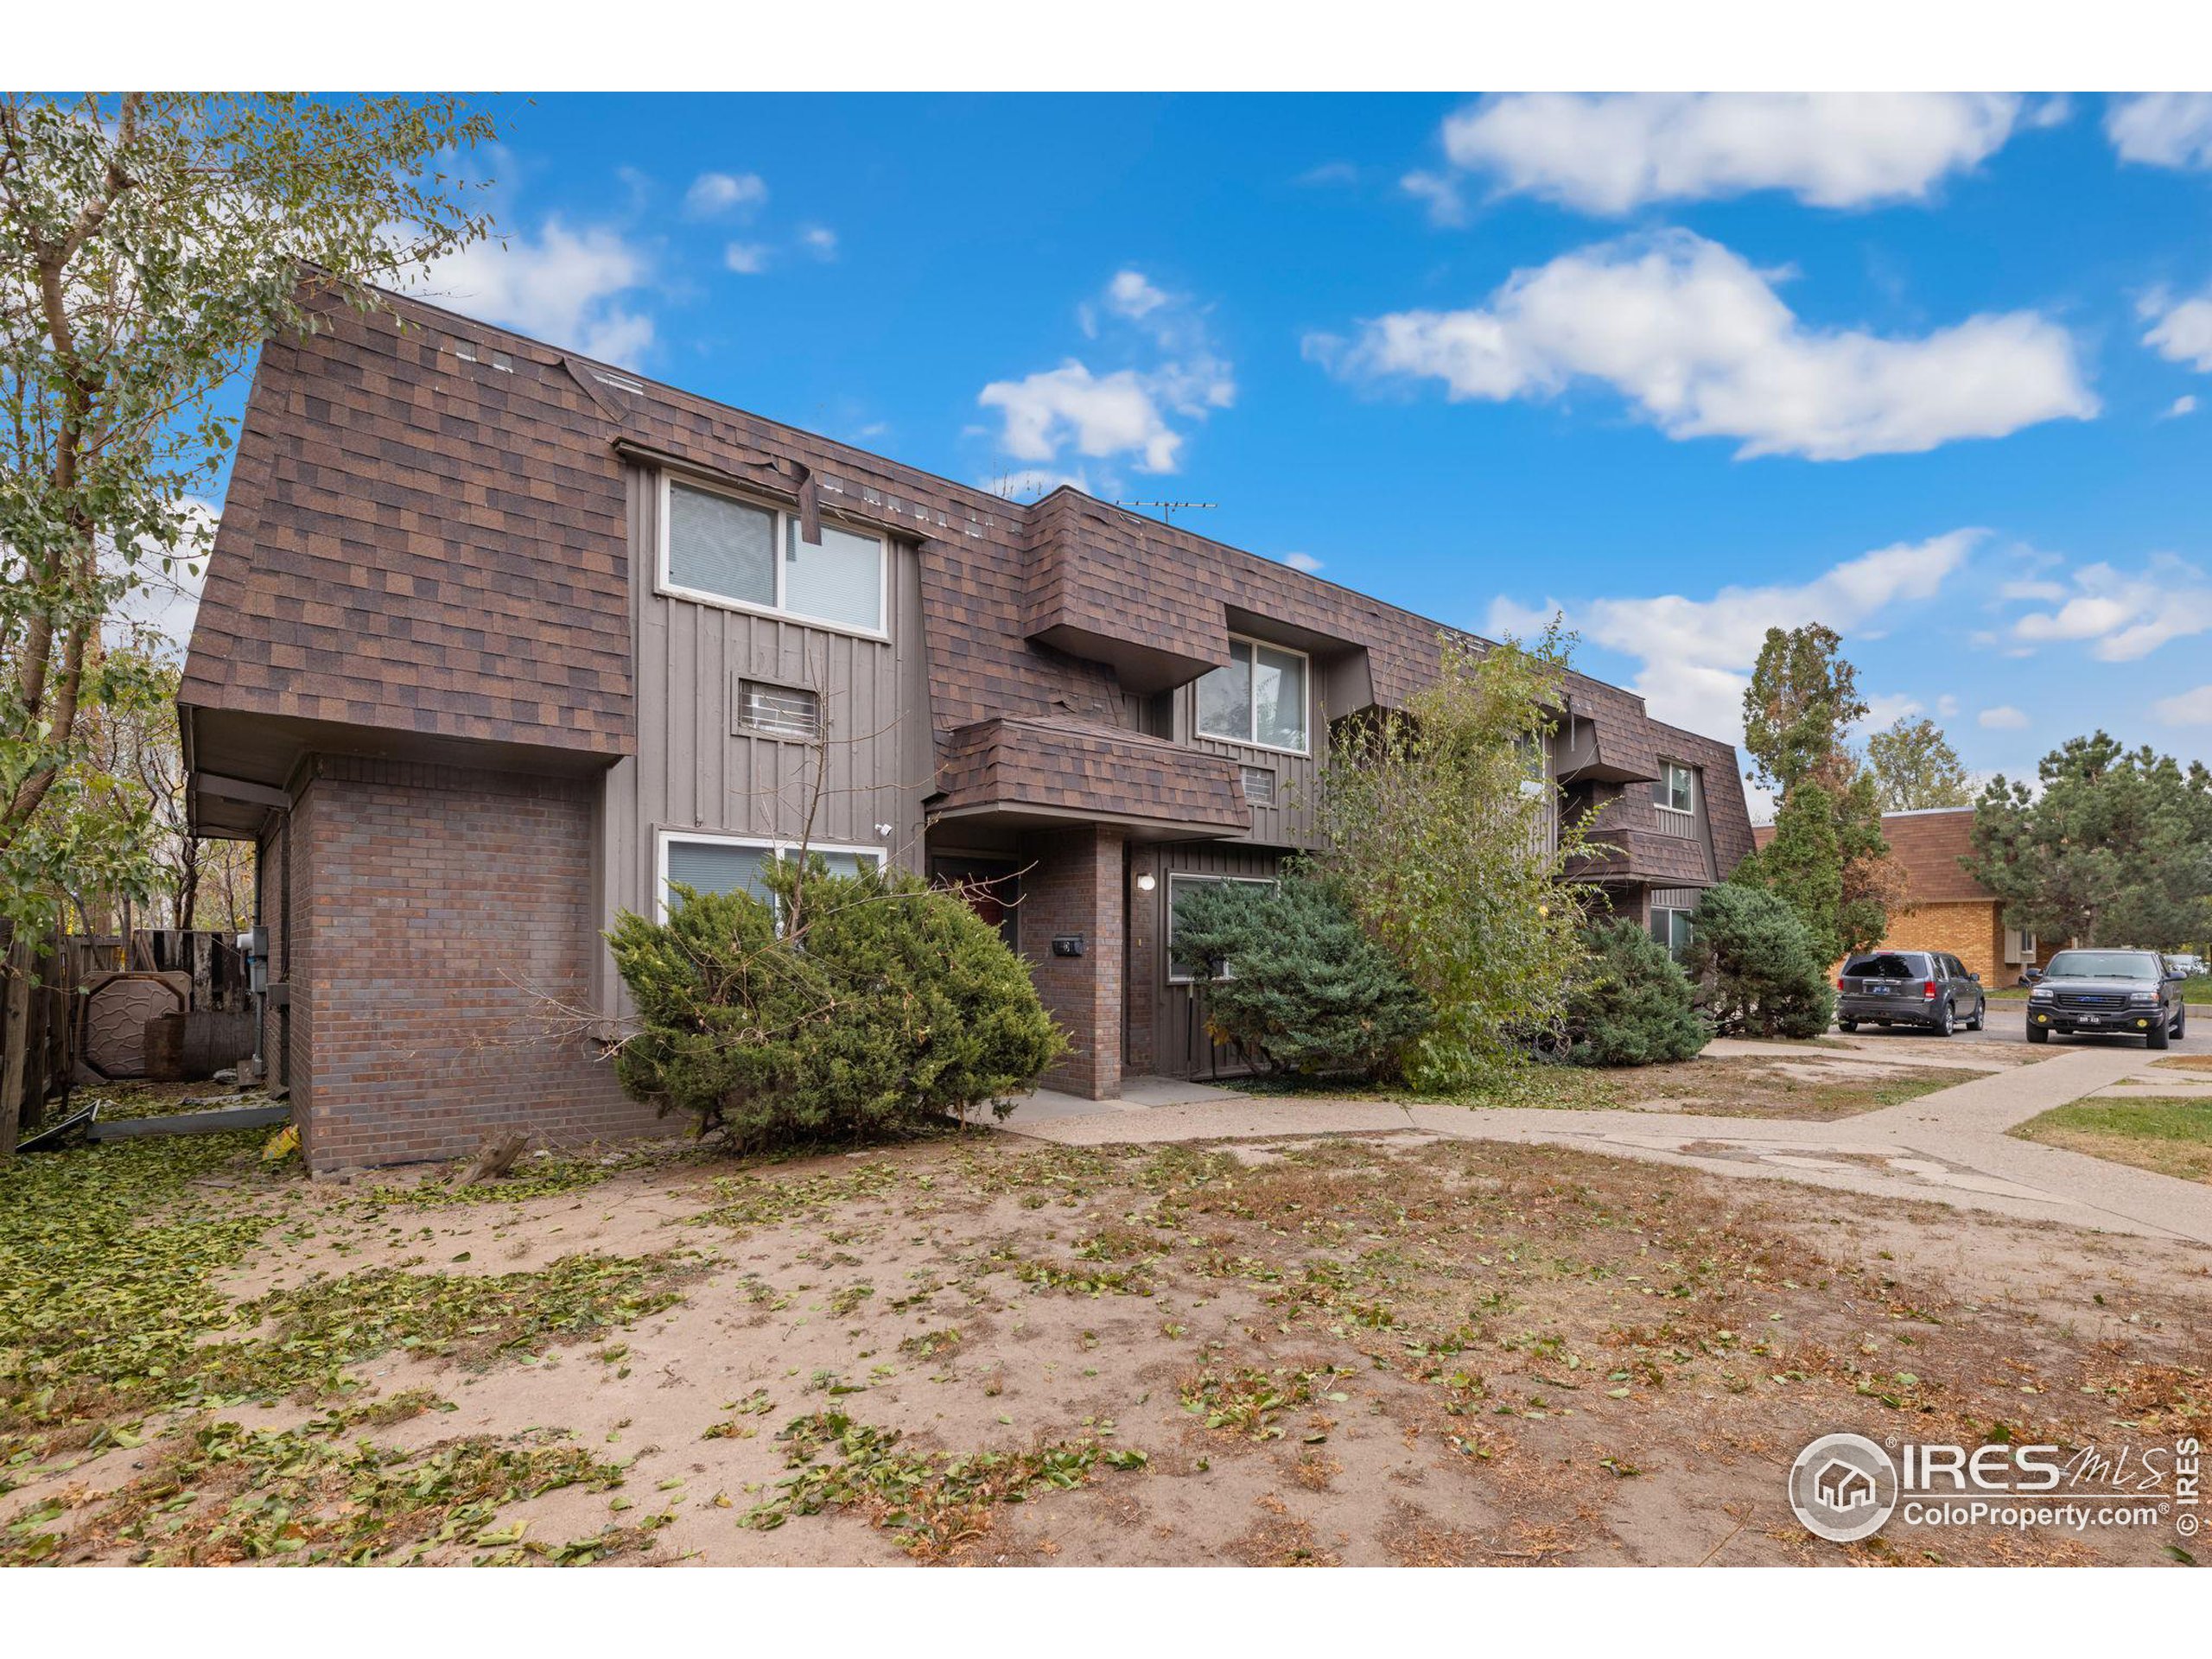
1732 624 1904 963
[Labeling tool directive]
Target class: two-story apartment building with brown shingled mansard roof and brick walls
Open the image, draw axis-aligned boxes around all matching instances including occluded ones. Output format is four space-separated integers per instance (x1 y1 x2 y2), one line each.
179 289 1750 1168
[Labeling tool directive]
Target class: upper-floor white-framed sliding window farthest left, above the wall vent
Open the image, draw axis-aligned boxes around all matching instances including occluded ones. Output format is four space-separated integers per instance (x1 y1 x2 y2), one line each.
657 474 892 639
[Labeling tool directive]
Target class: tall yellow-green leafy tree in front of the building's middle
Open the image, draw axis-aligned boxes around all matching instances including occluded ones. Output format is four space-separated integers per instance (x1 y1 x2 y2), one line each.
1319 626 1591 1090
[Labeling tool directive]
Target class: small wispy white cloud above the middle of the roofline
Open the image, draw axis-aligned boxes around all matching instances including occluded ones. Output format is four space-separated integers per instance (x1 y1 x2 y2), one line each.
976 270 1236 474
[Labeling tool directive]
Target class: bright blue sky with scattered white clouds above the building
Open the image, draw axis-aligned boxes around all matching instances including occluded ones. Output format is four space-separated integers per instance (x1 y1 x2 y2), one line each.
246 95 2212 814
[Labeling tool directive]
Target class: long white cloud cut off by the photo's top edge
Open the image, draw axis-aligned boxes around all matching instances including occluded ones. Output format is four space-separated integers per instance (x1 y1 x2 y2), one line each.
1442 93 2044 214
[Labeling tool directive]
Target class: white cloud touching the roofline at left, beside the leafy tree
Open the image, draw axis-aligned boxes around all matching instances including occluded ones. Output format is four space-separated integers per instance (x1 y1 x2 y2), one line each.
416 219 652 363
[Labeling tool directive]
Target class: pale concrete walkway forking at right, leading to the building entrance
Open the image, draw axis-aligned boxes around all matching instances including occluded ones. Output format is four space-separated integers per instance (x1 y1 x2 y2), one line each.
1002 1044 2212 1243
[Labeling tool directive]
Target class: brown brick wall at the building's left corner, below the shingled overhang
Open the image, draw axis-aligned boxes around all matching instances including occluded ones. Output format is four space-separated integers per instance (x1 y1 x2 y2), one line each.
289 757 655 1170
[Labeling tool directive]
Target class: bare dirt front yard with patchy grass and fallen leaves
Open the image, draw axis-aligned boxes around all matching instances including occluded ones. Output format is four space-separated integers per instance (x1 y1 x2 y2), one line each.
0 1133 2212 1566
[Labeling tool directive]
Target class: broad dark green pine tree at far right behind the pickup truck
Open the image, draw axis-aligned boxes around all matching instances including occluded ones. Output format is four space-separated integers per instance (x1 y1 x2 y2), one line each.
1962 732 2212 949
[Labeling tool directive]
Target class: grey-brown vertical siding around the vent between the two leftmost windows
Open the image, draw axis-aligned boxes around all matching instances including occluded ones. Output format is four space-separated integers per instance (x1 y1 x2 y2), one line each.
600 465 933 1007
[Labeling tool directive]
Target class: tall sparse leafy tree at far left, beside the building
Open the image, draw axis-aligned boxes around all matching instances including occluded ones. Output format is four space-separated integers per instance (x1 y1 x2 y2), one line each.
0 93 493 929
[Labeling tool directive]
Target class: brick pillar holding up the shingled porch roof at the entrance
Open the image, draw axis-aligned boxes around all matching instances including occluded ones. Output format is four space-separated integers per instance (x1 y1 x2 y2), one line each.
1022 827 1122 1099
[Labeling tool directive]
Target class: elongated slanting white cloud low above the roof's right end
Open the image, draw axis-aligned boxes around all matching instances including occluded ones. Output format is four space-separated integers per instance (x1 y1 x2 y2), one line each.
1489 529 1984 736
